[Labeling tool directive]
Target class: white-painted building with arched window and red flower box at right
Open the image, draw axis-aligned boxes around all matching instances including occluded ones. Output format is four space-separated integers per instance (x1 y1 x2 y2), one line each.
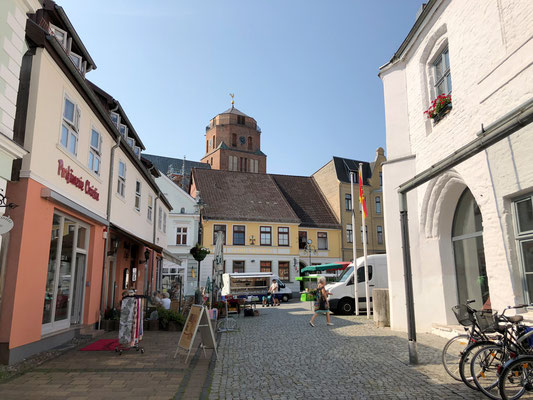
379 0 533 331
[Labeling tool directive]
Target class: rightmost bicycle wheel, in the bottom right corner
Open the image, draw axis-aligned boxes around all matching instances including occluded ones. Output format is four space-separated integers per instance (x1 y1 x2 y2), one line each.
498 356 533 400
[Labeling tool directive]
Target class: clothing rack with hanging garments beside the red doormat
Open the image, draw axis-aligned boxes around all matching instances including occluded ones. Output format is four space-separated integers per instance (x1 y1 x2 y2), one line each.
115 294 149 355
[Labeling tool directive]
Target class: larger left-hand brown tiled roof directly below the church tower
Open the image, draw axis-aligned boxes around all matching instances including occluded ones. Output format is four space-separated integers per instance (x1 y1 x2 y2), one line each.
192 168 300 223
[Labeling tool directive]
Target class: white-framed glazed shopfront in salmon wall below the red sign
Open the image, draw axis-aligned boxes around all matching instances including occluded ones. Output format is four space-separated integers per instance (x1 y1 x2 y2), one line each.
41 212 89 335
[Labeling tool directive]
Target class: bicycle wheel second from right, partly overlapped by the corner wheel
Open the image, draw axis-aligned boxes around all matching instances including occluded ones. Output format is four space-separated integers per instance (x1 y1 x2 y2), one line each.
470 345 507 400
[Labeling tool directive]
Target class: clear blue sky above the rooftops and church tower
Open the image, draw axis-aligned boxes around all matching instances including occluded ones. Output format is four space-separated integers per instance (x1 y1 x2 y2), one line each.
56 0 422 175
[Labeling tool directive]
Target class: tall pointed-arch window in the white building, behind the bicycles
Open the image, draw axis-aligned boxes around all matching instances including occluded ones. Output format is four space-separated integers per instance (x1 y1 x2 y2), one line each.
452 189 490 308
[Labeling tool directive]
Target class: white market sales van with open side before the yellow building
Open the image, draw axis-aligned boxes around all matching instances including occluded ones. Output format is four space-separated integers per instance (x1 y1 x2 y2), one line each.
221 272 292 302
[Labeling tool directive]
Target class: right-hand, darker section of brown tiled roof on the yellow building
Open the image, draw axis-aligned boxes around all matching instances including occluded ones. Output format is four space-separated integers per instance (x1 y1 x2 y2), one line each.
271 175 340 229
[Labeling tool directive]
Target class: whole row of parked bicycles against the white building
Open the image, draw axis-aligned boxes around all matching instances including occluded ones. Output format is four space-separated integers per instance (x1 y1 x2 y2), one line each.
442 300 533 400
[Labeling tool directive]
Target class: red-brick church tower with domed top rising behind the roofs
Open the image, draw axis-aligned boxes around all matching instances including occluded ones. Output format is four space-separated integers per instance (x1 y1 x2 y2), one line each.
201 101 266 174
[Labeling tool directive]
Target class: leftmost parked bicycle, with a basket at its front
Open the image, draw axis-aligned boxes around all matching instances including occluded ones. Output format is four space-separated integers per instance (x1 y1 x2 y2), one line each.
441 300 490 381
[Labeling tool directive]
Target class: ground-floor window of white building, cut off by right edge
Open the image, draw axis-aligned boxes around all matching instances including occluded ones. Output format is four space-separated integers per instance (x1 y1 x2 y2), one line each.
513 195 533 303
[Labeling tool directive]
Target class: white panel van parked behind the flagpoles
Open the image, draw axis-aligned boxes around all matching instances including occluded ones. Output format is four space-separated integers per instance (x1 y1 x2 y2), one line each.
326 254 389 314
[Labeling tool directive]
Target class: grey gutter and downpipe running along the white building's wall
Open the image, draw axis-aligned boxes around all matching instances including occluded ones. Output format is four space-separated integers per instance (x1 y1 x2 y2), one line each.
398 99 533 364
